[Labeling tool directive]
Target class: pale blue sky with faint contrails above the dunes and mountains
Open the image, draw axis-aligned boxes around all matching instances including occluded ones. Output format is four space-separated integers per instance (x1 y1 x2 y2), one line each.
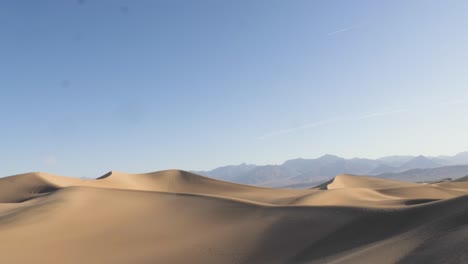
0 0 468 177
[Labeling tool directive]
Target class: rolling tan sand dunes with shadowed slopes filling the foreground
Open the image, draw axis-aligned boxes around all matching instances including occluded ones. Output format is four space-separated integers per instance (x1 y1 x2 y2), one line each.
0 170 468 264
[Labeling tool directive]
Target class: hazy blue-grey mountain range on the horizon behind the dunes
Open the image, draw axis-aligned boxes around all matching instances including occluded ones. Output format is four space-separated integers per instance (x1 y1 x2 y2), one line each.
194 151 468 188
